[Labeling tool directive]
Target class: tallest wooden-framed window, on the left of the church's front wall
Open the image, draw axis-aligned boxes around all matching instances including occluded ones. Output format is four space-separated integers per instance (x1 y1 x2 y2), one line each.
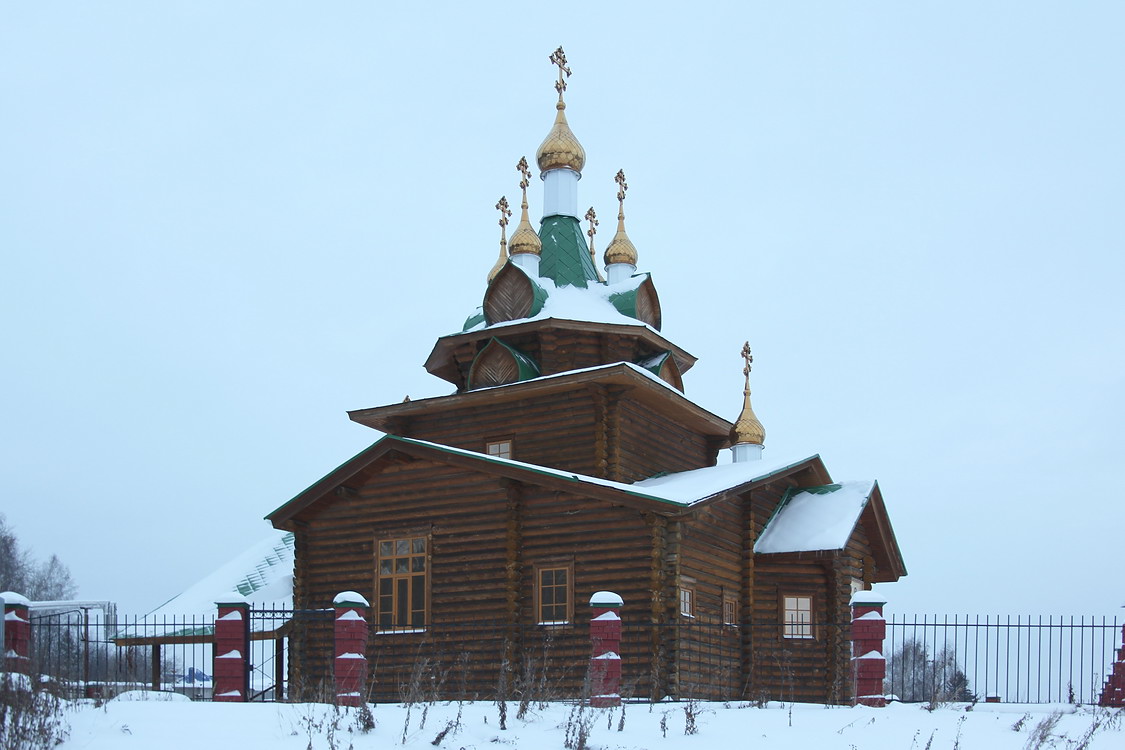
376 536 429 630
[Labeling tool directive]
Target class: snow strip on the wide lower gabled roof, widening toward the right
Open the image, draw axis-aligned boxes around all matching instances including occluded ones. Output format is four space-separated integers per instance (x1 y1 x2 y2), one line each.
394 436 819 506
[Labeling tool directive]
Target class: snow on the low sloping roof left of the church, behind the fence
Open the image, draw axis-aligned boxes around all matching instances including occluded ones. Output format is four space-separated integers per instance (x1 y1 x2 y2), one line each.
147 532 294 617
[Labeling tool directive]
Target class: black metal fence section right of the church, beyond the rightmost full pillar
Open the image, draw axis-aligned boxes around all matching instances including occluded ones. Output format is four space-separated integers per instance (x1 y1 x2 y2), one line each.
883 615 1122 704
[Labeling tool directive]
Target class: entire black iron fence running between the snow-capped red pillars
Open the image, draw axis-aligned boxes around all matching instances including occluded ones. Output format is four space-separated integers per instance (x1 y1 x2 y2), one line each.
19 608 1122 704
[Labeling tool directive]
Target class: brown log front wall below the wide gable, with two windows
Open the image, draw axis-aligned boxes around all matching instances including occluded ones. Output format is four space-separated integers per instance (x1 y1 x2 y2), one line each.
290 460 675 701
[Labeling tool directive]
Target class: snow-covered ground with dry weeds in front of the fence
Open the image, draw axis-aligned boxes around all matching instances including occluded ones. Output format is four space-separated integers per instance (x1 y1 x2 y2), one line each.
60 694 1125 750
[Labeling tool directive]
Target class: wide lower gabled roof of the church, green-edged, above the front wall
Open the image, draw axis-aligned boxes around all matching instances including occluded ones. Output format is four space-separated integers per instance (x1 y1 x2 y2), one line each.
266 435 827 528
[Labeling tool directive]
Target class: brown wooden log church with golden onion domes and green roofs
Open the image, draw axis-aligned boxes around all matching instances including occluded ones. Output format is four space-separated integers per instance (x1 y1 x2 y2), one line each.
267 48 906 702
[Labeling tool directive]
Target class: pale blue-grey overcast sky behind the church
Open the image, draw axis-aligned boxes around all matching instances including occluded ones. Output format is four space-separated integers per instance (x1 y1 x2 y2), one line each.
0 0 1125 615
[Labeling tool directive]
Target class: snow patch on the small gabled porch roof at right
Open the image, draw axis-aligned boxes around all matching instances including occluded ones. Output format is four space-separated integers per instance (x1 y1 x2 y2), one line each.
756 483 875 554
